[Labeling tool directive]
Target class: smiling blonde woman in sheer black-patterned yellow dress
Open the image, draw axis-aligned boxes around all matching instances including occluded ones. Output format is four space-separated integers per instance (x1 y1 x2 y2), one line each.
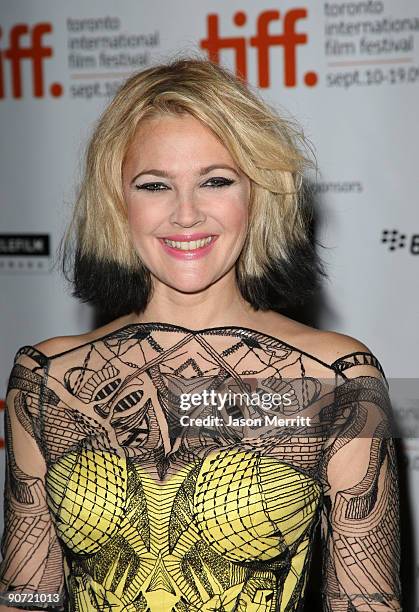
0 59 401 612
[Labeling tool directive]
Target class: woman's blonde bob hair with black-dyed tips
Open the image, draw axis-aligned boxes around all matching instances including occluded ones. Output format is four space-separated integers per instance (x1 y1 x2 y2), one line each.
63 57 323 310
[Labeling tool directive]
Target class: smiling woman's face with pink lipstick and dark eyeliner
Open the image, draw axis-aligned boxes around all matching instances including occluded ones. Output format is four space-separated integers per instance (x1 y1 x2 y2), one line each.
123 115 250 293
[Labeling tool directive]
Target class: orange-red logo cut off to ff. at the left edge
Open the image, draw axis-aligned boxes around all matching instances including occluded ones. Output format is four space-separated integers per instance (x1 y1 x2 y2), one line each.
0 23 63 99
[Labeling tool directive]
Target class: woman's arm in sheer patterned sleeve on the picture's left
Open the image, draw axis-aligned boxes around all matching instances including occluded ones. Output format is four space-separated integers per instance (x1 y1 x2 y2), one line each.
0 353 64 610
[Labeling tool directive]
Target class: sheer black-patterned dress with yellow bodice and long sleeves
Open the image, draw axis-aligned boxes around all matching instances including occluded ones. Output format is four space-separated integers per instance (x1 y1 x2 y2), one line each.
0 323 401 612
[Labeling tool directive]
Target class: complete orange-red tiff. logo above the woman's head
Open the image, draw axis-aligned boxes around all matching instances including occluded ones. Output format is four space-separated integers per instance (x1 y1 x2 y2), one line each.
200 8 318 87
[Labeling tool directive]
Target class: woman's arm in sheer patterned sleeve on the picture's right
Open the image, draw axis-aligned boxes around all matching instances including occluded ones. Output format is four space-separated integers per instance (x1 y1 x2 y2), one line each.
321 358 402 612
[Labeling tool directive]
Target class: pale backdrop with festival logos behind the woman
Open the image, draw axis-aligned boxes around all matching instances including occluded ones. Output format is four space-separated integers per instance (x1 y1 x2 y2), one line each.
0 0 419 610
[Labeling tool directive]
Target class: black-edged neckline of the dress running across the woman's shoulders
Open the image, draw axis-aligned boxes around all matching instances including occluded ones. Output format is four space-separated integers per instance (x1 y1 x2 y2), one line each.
13 321 385 377
